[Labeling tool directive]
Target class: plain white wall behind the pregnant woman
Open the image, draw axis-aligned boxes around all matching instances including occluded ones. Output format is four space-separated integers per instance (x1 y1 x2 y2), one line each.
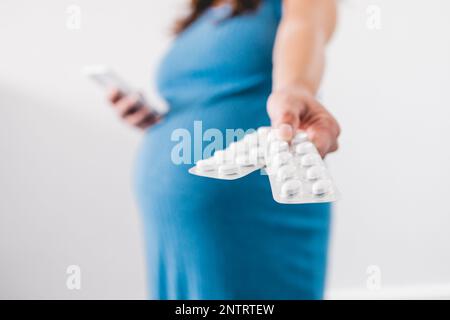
0 0 450 298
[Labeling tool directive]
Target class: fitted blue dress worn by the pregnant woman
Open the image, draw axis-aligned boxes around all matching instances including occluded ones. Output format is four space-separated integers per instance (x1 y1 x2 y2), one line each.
135 0 330 299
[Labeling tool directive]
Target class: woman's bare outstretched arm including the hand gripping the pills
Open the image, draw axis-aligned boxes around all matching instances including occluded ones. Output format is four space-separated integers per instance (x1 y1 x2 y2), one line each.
267 0 340 156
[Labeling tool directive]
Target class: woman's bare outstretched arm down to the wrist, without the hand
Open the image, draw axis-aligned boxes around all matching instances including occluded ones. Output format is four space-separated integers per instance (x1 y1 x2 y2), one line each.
273 0 336 93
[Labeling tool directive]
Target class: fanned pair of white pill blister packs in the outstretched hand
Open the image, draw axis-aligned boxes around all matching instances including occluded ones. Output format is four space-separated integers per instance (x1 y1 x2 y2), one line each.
189 127 339 204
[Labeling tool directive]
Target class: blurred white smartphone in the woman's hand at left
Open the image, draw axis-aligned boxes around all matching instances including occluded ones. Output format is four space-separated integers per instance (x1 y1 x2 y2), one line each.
82 65 169 116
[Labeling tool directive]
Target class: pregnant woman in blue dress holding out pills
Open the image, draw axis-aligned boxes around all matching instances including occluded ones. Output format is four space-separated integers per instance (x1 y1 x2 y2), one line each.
110 0 339 299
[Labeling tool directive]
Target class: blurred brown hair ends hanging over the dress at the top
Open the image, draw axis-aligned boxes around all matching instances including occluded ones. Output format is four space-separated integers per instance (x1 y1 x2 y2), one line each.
175 0 261 34
